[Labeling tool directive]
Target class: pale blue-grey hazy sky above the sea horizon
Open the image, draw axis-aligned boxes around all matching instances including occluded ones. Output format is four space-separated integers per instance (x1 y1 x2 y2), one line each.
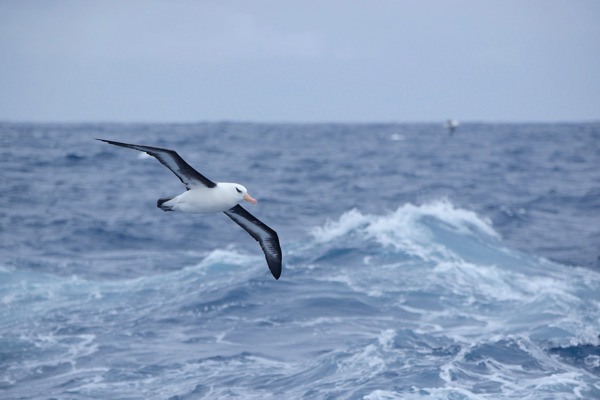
0 0 600 123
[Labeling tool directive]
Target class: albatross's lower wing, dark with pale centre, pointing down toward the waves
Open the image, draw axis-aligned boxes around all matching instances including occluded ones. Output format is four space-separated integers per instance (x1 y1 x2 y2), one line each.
223 204 281 279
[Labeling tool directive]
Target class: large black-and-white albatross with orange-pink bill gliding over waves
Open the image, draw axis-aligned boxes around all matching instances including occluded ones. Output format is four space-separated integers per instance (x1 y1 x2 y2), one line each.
96 139 282 279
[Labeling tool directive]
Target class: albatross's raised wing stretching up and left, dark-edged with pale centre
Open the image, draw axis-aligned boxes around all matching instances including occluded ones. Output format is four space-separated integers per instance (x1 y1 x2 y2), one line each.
96 139 217 190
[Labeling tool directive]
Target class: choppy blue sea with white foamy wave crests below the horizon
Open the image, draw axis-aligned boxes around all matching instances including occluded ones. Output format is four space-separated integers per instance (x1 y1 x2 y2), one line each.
0 123 600 400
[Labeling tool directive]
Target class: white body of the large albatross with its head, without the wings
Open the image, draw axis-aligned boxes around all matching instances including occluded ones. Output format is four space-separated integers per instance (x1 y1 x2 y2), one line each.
161 182 256 214
